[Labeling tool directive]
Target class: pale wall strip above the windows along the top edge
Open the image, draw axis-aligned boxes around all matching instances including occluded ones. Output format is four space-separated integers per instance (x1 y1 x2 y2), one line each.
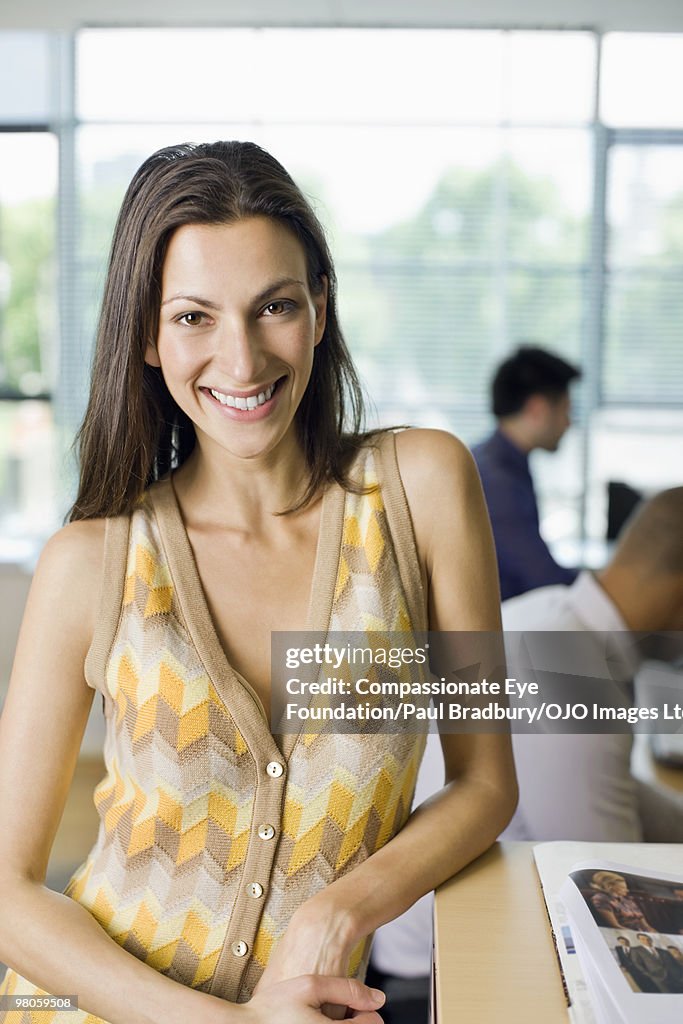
0 0 683 32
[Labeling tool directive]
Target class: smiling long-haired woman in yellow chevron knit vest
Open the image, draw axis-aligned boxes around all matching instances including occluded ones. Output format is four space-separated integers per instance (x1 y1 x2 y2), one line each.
0 142 515 1024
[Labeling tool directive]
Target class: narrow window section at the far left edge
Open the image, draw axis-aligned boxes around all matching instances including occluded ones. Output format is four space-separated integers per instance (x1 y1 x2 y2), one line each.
0 33 59 544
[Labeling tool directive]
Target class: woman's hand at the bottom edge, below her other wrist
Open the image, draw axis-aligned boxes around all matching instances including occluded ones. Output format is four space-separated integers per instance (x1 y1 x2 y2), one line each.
240 974 384 1024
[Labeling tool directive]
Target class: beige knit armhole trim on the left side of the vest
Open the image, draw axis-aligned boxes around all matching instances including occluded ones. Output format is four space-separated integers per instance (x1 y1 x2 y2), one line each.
85 515 131 695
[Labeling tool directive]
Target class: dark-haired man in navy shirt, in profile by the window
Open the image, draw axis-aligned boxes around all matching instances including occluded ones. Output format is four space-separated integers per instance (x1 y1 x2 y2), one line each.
472 347 581 600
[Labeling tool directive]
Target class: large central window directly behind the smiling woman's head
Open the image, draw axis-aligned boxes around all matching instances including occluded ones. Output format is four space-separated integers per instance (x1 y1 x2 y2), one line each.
77 29 596 548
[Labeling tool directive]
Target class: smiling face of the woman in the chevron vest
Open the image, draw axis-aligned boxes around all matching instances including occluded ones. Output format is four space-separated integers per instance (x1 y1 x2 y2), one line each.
146 217 327 468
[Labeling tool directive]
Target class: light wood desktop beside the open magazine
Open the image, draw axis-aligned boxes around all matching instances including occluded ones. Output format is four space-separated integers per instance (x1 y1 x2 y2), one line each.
434 843 567 1024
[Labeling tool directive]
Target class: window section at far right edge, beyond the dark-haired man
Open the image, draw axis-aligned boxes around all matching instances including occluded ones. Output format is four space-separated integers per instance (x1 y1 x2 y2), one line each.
586 33 683 535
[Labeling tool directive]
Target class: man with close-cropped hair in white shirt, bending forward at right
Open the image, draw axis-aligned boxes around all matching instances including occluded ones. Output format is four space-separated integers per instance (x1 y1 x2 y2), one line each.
373 486 683 991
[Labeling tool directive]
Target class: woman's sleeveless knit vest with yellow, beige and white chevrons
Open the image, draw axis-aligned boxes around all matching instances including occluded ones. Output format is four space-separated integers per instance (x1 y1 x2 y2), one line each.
0 434 427 1024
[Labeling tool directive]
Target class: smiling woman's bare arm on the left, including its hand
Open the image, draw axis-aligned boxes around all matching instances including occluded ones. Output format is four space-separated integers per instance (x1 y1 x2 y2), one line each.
0 520 379 1024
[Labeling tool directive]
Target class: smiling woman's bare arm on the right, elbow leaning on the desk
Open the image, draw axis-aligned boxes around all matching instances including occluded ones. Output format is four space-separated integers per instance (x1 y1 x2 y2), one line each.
259 430 517 978
